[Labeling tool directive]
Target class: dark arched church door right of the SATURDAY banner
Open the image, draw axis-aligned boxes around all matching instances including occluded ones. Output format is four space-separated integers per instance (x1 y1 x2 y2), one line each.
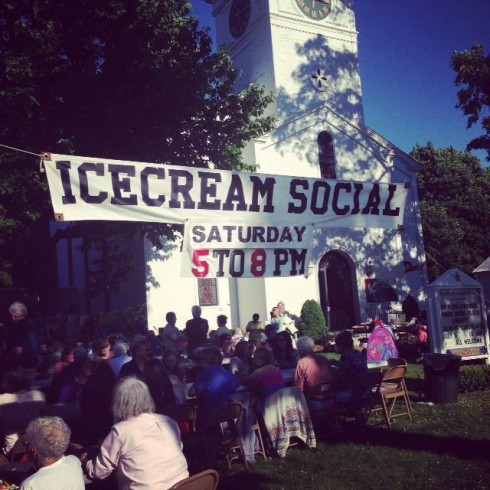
318 251 356 332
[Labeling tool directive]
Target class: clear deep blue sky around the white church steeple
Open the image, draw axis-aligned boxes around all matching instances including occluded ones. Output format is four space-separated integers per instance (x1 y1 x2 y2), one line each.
192 0 490 163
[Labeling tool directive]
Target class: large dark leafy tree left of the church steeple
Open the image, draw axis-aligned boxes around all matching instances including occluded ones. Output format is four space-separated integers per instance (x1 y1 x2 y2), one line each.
0 0 274 296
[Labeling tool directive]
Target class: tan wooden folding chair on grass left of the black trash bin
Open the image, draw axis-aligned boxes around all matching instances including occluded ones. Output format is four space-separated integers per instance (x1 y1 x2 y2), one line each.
368 365 412 428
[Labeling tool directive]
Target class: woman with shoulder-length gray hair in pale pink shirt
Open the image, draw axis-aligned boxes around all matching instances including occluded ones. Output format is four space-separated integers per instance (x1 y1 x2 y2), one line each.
82 377 189 490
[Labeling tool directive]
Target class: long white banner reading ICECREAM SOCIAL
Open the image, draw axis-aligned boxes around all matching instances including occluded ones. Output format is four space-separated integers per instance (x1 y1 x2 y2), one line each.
44 154 408 228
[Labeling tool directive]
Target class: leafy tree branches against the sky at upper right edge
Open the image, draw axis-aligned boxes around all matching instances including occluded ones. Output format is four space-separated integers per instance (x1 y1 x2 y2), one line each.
451 44 490 161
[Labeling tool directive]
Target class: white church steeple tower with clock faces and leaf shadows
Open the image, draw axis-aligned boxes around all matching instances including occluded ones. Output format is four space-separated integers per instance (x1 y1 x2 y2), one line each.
213 0 363 123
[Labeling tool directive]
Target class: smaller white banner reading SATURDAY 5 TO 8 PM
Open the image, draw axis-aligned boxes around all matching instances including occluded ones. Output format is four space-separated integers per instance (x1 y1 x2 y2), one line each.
181 221 312 278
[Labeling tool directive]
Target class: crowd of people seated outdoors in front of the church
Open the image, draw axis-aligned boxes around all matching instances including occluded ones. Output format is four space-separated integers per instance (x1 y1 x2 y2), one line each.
0 300 376 485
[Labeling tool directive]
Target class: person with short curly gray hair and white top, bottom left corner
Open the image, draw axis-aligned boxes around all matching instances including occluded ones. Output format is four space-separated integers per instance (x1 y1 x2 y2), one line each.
20 417 85 490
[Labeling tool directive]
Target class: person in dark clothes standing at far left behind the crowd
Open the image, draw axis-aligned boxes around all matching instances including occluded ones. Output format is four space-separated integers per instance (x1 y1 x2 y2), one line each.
7 301 39 388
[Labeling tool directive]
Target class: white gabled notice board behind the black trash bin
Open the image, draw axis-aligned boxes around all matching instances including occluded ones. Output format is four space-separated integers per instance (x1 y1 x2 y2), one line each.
427 269 490 364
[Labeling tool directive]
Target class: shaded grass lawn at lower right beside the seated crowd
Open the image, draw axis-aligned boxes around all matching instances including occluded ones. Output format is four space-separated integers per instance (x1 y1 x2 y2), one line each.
218 365 490 490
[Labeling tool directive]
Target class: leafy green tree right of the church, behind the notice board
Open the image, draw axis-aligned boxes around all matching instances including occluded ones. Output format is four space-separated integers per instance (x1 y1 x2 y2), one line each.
411 143 490 280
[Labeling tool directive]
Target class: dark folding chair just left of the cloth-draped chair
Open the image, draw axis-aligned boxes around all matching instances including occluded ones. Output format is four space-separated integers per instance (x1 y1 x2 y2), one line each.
204 402 248 471
